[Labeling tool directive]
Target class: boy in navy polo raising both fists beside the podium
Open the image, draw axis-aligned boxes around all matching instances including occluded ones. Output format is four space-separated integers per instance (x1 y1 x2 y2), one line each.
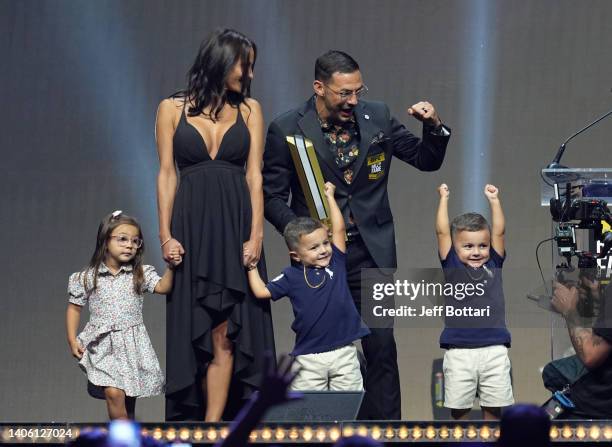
436 184 514 419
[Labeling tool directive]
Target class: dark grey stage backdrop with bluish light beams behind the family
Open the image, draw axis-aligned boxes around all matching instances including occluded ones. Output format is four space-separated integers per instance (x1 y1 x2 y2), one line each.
0 0 612 421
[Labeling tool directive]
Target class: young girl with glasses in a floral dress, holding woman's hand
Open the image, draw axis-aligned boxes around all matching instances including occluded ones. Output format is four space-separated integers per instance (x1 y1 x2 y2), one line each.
66 211 182 419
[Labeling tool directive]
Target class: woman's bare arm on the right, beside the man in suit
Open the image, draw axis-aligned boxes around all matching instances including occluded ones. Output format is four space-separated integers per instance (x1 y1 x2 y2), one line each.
243 98 264 267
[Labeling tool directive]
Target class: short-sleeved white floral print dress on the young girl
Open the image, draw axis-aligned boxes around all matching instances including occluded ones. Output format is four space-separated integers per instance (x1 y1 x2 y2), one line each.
68 264 164 399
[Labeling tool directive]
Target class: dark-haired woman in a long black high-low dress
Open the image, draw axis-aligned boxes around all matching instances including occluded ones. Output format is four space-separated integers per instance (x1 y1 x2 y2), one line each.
156 29 274 422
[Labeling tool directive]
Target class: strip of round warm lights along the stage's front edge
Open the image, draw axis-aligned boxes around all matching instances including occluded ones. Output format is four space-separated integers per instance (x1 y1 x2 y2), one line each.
0 421 612 444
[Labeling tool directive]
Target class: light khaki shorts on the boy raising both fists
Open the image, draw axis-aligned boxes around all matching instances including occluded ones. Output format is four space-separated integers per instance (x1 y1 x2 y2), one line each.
442 345 514 409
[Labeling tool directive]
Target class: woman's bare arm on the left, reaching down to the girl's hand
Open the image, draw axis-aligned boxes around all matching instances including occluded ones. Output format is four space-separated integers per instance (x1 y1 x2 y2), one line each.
155 99 184 261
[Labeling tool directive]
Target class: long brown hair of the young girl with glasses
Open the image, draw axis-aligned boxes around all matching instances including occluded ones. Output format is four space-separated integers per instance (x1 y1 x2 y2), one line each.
81 211 144 297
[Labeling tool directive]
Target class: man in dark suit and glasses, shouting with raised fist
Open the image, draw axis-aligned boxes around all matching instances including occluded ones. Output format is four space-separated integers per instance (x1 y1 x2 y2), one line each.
263 50 450 419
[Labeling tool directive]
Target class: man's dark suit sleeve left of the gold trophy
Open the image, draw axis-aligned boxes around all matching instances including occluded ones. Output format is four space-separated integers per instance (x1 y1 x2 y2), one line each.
263 122 296 234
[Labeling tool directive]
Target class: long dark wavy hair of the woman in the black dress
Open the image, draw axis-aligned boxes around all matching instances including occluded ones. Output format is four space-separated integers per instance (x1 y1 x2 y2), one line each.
184 28 257 121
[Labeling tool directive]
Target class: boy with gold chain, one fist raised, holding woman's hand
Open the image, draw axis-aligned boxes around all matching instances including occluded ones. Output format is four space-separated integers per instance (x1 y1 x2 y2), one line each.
248 182 370 391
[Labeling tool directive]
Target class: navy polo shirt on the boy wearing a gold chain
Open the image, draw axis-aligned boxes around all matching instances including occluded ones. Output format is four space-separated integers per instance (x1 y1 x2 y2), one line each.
266 245 370 356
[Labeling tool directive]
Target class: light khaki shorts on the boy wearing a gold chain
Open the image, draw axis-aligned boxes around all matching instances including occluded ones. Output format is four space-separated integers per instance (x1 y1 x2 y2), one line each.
291 344 363 391
